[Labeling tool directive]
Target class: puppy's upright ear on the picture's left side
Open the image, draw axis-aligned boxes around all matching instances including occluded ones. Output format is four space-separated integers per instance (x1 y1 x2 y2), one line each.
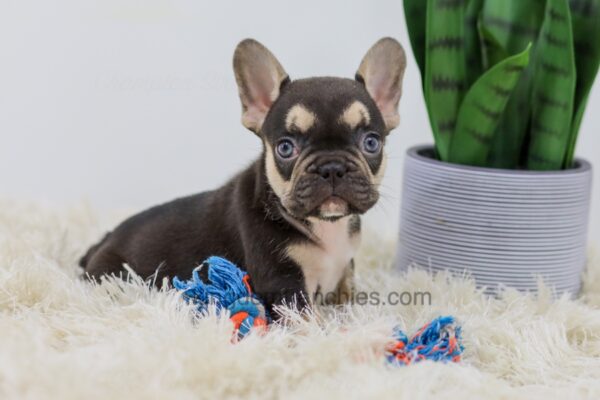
233 39 289 133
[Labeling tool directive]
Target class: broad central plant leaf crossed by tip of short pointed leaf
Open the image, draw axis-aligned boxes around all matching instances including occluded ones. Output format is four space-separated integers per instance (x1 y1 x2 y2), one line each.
481 0 546 168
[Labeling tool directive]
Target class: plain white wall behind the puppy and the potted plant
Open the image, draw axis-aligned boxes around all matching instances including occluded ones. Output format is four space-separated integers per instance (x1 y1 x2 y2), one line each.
0 0 600 245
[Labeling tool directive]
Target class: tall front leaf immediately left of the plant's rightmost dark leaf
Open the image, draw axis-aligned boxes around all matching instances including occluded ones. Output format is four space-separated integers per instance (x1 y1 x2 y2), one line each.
527 0 576 170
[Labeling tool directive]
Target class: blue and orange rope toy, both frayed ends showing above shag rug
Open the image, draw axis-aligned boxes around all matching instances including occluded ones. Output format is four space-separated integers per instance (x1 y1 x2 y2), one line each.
173 257 464 365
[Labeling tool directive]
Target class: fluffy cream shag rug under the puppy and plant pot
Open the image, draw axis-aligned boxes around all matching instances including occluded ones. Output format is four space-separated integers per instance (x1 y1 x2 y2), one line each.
0 201 600 400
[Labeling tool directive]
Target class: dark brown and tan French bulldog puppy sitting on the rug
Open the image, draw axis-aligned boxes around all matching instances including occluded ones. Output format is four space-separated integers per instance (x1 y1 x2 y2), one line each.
80 38 406 311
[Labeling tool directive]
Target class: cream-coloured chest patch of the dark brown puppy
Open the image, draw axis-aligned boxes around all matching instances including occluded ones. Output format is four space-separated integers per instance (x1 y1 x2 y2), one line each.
287 217 360 298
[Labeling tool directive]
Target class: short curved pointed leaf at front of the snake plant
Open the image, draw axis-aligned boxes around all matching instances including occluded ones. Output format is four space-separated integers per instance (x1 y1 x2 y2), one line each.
448 46 531 166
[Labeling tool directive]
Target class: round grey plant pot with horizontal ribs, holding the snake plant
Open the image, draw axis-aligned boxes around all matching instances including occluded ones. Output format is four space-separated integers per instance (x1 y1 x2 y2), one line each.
398 146 592 296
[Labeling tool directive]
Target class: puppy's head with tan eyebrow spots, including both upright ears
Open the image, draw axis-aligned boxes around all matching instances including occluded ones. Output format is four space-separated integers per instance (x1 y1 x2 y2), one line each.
234 38 406 220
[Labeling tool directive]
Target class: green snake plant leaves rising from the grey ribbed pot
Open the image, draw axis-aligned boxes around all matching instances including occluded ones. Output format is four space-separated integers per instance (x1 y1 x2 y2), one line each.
404 0 600 170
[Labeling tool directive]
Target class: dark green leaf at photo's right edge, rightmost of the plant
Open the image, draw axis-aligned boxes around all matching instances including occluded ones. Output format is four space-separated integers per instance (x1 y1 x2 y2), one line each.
564 0 600 168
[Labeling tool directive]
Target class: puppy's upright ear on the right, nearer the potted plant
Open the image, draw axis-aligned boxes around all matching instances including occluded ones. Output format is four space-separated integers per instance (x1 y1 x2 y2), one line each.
356 38 406 130
